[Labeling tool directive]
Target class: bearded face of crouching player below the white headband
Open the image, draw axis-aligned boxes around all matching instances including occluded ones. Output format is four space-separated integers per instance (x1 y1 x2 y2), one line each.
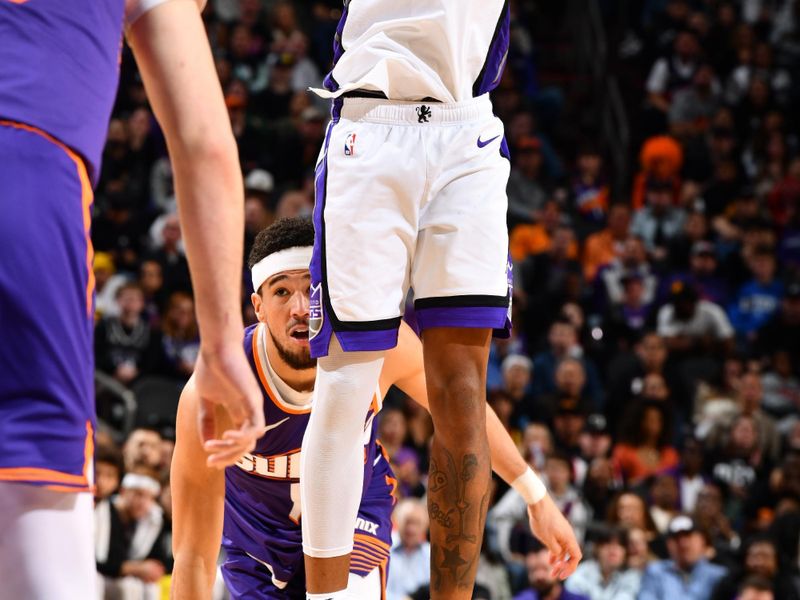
253 269 316 369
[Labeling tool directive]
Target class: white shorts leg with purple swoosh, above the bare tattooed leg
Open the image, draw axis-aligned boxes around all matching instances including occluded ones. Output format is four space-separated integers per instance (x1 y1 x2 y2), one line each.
411 118 510 329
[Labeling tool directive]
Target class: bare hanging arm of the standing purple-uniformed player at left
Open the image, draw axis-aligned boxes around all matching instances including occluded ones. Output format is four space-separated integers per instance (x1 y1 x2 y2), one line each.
126 0 264 467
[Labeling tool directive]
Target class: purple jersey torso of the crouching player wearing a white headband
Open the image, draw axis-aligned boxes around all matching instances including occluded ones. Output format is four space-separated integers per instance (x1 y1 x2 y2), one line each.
223 325 391 581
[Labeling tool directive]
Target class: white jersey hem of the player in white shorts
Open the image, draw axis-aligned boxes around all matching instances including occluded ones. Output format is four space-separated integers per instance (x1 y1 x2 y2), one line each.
314 0 510 103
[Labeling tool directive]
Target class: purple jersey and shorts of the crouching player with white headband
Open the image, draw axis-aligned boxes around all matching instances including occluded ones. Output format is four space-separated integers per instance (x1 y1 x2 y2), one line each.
222 325 395 590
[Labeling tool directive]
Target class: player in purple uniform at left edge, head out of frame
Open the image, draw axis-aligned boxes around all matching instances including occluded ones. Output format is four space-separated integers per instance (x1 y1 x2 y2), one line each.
0 0 264 600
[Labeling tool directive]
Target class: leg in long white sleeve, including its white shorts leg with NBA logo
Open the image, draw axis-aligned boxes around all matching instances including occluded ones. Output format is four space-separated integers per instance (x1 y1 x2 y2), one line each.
300 106 424 598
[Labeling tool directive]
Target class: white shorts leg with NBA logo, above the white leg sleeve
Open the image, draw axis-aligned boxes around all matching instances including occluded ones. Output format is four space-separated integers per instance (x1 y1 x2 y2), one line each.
310 120 425 356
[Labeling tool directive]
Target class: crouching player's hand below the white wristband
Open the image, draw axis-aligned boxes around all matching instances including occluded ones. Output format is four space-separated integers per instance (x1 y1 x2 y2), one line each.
528 495 583 581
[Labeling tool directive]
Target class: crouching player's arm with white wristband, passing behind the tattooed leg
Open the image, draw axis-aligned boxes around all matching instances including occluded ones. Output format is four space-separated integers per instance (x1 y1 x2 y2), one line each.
380 323 582 579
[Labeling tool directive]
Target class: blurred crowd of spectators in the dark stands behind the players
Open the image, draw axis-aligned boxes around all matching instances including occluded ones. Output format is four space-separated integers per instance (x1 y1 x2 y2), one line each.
92 0 800 600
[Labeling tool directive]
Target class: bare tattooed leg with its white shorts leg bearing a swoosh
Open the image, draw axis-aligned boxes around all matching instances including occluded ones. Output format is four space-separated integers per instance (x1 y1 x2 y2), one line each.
412 99 510 600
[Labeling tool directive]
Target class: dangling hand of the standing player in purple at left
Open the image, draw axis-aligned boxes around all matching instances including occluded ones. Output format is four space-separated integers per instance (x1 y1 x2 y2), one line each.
194 341 264 469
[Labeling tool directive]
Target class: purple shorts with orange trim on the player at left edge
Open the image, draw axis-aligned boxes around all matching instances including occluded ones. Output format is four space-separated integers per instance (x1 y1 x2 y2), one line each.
0 125 94 487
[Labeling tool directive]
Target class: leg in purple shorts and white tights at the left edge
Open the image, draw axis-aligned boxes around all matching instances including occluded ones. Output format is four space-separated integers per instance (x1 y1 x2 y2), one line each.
0 123 95 599
